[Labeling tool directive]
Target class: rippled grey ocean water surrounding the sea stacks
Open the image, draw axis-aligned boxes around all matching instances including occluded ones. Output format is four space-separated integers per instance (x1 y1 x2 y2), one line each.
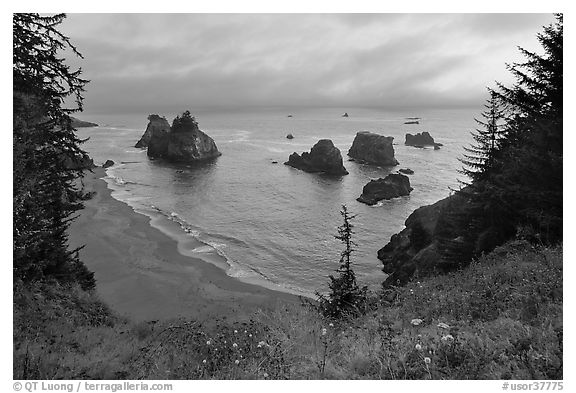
78 108 478 297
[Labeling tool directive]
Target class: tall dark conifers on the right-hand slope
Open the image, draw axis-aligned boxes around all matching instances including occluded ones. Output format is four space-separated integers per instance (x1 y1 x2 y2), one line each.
439 15 563 266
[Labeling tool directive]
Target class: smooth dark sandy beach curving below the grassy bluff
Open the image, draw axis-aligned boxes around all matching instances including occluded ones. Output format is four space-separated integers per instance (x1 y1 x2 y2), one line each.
69 168 299 320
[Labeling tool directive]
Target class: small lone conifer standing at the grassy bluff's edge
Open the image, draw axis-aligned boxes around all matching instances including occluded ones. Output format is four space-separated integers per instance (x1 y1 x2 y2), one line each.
317 205 366 318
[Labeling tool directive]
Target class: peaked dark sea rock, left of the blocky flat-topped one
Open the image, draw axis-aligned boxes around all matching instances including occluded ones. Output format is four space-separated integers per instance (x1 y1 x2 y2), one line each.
284 139 348 175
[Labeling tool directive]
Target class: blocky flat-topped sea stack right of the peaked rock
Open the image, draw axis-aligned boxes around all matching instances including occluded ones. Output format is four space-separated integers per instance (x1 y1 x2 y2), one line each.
348 131 398 166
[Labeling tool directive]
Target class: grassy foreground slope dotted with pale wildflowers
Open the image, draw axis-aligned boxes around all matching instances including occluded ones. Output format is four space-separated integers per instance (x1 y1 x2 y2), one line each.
14 243 563 379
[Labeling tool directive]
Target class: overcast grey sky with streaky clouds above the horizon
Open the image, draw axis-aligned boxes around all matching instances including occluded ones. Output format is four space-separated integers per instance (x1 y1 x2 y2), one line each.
62 14 554 113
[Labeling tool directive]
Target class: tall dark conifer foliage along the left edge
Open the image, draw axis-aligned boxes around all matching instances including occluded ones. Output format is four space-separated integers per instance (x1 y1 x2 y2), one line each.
13 14 95 288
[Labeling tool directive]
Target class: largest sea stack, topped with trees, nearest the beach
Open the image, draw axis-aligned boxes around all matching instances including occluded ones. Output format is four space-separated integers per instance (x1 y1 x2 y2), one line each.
143 111 222 163
